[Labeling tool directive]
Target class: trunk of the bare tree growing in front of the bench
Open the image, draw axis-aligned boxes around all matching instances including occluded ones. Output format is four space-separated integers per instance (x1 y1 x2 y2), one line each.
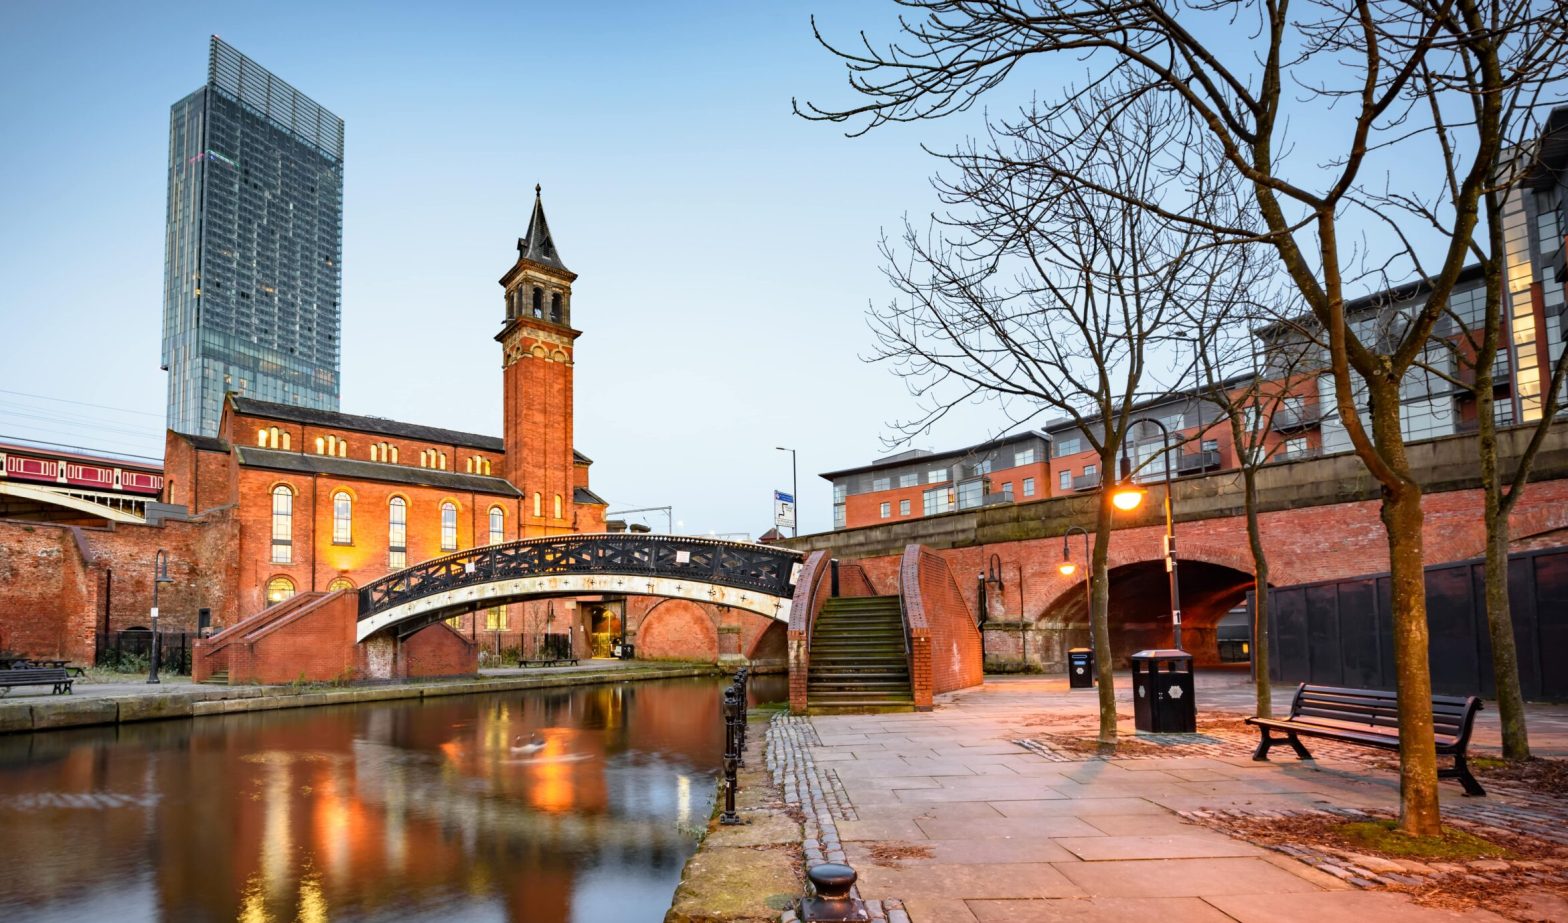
1369 388 1441 837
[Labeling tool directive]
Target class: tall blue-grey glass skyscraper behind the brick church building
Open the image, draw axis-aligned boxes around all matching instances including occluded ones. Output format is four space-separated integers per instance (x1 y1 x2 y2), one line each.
163 36 343 436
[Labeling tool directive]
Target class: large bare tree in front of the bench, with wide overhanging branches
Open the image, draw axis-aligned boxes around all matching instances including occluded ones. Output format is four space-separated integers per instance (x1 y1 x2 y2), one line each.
803 0 1568 835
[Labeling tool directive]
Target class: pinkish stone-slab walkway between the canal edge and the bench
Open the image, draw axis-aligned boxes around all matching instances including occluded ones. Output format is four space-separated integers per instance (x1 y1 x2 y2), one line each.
806 674 1568 923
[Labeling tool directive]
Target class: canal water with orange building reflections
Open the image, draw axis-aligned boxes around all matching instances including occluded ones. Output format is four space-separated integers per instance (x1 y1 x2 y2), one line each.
0 677 784 923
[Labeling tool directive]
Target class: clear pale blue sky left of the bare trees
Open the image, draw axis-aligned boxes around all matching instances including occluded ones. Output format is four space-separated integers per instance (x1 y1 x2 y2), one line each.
0 0 1028 536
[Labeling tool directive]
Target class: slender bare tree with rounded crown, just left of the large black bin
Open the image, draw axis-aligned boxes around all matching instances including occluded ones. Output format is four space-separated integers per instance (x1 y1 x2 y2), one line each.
872 94 1226 741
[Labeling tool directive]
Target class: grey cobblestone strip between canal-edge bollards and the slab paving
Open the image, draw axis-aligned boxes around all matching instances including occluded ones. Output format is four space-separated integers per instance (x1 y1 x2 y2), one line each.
767 715 909 923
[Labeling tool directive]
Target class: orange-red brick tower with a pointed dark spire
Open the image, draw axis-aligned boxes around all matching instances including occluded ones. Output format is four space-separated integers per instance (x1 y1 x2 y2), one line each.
495 186 582 536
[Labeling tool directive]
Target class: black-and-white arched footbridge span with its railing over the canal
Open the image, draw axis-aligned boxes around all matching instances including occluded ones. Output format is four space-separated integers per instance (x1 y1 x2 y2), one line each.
354 533 801 642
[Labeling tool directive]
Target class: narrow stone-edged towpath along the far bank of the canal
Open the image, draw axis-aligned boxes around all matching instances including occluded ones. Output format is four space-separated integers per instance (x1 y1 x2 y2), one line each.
0 660 733 733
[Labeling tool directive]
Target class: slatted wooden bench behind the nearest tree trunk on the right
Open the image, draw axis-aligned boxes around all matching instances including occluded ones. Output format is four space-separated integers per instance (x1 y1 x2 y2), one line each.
1247 683 1486 795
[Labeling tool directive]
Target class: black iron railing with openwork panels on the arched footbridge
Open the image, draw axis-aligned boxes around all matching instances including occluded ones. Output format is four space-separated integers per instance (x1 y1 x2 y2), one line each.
359 533 803 619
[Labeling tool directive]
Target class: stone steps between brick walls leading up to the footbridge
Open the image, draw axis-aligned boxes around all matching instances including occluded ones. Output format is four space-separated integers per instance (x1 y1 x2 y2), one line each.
806 595 914 713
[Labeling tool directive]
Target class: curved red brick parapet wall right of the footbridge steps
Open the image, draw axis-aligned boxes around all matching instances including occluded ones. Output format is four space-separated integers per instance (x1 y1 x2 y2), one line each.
900 545 985 711
